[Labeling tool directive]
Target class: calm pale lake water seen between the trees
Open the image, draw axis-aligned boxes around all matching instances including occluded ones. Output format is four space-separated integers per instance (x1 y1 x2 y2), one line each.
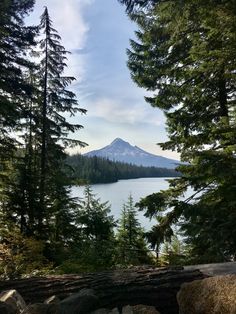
72 178 171 230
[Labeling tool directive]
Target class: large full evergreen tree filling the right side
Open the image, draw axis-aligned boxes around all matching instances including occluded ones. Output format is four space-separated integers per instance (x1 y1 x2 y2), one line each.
123 0 236 261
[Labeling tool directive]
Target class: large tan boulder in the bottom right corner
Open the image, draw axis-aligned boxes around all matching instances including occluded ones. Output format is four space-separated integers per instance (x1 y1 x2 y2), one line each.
177 275 236 314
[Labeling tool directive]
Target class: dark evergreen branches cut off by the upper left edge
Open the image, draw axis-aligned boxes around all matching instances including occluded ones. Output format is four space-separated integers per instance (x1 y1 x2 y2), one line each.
0 0 35 159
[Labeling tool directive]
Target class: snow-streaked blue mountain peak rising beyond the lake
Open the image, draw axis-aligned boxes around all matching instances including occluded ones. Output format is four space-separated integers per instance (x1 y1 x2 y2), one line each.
84 138 180 169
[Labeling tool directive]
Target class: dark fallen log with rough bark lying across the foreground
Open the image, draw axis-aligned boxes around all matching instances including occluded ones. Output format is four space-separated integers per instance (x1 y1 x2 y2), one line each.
0 268 205 314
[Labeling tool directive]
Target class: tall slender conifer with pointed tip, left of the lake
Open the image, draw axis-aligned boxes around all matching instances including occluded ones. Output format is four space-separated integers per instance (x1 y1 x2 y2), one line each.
1 9 85 264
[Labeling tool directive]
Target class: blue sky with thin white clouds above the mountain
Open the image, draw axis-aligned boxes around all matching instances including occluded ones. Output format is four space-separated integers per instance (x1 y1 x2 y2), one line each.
28 0 178 158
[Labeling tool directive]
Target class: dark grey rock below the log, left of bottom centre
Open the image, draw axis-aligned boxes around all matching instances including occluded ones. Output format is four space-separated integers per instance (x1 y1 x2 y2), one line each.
60 289 98 314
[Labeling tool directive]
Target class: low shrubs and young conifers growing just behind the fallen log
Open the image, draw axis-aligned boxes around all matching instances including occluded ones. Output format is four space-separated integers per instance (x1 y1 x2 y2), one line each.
0 186 154 279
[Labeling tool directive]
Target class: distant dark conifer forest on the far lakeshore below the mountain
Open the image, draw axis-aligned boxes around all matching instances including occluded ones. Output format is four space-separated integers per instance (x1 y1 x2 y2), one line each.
67 155 180 184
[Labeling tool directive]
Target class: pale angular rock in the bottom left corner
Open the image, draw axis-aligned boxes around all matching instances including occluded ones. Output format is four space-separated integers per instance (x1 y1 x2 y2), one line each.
0 289 26 313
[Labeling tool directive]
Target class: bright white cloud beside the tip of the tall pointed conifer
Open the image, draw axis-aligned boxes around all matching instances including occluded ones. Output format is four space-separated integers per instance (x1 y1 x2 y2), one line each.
27 0 94 81
